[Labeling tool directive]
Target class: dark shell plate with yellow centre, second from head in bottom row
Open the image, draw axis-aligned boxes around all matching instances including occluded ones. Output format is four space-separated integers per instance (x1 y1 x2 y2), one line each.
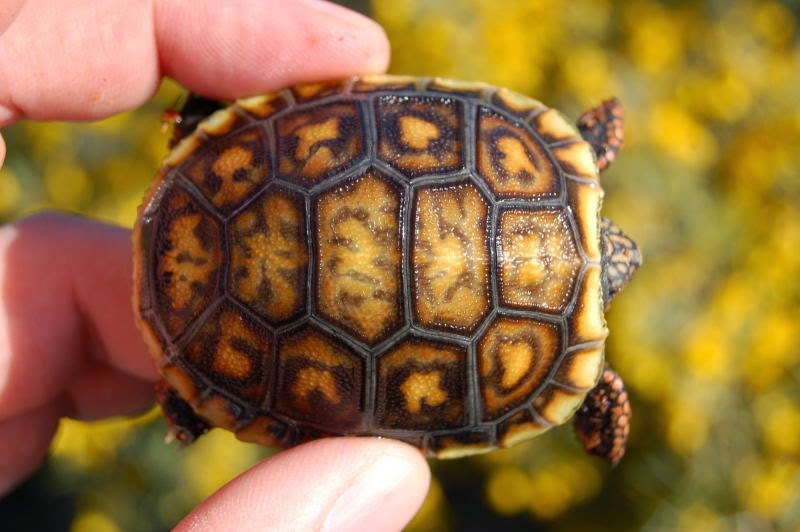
375 338 469 430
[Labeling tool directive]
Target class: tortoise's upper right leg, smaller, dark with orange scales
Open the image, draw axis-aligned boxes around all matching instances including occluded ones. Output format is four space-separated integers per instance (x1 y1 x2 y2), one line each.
578 98 624 172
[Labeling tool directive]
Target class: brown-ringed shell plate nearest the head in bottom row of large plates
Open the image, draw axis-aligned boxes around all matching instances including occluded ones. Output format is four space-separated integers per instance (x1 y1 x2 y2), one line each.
477 317 562 421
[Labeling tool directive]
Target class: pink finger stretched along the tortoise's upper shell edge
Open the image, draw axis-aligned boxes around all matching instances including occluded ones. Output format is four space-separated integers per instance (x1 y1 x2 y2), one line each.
0 0 389 127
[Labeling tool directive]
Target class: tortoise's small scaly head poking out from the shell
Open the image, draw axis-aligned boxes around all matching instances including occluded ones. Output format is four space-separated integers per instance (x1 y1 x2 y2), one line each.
600 218 642 309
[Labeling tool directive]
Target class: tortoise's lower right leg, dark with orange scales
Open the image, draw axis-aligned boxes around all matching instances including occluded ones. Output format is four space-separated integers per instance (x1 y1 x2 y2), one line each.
574 366 632 466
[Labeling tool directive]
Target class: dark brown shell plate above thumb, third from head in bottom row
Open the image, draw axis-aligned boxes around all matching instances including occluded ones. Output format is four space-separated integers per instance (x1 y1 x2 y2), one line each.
275 327 365 433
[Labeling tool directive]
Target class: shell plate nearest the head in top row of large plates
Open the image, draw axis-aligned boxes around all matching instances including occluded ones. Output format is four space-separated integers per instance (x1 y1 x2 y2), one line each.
476 106 561 199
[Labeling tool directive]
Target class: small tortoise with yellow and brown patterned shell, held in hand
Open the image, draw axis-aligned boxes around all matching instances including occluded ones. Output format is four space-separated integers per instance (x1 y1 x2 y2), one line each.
133 72 641 463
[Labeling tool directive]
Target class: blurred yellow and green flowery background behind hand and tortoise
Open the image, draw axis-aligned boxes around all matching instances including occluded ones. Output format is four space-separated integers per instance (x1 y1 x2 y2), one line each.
0 0 800 532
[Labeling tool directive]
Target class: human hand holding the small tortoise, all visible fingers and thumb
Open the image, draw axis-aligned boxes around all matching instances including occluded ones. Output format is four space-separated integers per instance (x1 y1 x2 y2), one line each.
0 0 430 530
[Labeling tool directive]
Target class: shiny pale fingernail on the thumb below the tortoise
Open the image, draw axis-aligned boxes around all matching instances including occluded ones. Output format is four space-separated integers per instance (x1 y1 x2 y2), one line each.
322 455 411 532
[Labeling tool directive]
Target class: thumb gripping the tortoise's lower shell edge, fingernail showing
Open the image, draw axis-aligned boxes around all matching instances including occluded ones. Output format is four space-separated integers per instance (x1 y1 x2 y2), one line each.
176 438 430 532
